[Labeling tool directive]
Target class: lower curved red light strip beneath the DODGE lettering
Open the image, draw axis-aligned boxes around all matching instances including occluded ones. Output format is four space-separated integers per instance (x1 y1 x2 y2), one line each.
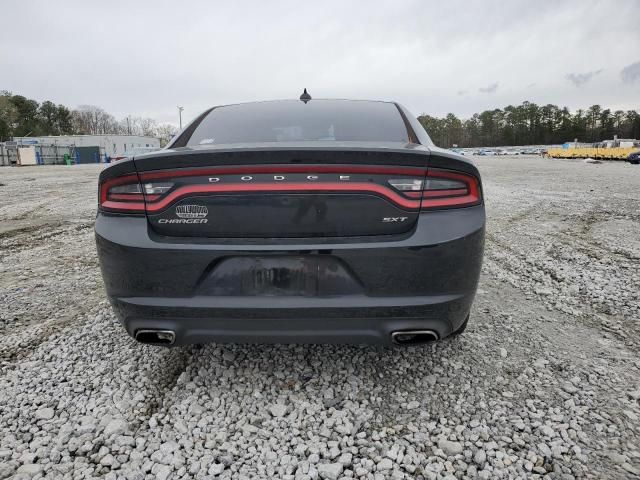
147 182 420 213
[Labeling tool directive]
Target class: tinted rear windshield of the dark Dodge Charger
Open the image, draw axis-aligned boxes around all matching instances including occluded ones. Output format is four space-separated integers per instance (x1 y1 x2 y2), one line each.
178 100 409 147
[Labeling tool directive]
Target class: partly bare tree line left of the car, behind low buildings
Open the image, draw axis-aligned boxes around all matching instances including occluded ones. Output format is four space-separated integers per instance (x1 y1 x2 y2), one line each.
0 90 177 145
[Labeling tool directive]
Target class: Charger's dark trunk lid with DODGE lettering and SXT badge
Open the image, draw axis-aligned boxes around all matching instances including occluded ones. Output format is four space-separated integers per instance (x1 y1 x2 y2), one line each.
135 145 428 238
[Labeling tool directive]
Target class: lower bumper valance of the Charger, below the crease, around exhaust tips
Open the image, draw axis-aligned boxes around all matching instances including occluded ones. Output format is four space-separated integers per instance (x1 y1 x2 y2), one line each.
112 295 473 344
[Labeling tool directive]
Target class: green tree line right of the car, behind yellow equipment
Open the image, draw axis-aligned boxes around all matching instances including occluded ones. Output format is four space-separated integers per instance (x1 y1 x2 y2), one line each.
418 102 640 148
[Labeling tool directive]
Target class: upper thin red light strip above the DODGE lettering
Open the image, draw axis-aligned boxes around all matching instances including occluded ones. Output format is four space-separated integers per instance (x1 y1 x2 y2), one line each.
140 164 426 181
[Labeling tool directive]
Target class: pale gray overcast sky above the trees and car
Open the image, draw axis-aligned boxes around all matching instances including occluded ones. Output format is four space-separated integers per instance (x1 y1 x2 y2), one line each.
0 0 640 124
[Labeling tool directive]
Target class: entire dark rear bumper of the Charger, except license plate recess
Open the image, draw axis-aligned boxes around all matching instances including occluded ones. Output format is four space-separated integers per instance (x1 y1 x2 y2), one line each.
96 206 485 344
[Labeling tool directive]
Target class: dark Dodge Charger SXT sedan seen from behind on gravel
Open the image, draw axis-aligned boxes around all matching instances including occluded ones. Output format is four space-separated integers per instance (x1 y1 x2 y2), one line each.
95 97 485 345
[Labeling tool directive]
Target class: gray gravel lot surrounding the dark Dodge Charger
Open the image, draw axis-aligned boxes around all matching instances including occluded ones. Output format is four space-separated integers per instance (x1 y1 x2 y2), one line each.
0 157 640 480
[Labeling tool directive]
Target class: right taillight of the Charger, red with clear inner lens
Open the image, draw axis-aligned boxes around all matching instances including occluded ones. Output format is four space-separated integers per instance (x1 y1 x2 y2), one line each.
388 170 482 210
